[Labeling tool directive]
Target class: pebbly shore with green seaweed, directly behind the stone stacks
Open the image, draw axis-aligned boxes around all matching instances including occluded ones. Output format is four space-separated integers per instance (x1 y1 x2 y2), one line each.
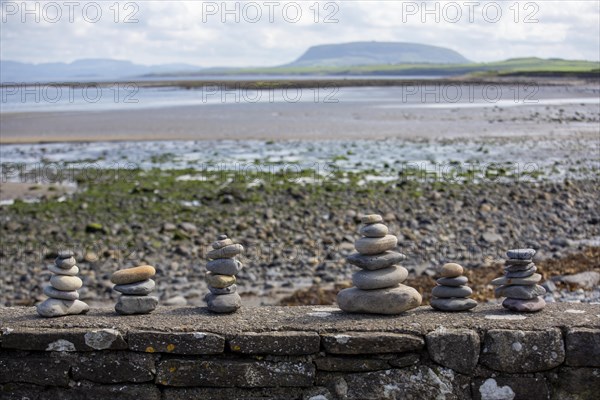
0 162 600 306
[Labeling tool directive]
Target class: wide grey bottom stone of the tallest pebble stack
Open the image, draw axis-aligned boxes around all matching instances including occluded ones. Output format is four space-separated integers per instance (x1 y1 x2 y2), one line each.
337 284 422 315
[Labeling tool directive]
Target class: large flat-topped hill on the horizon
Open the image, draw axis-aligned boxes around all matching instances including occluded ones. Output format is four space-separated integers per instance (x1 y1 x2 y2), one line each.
286 42 469 67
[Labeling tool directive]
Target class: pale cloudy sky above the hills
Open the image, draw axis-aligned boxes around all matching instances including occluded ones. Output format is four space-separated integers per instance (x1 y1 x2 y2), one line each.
0 0 600 66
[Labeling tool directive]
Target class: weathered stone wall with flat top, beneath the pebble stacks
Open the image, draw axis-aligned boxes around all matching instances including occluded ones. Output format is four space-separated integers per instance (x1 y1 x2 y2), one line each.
0 303 600 400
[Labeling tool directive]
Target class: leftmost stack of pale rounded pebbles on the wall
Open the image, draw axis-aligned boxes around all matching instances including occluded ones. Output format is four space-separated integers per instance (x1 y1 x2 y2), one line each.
37 250 90 317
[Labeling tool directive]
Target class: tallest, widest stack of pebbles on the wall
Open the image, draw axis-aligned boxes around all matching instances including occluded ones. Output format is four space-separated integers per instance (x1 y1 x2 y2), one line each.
337 214 421 314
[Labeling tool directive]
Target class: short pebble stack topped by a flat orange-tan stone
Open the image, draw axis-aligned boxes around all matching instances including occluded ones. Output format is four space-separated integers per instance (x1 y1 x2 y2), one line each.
110 265 158 315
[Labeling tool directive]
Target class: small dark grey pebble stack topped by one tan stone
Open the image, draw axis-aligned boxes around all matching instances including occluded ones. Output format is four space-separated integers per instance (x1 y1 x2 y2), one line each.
431 263 477 311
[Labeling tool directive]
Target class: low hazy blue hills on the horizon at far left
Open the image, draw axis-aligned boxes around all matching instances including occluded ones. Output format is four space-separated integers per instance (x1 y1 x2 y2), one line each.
0 58 200 83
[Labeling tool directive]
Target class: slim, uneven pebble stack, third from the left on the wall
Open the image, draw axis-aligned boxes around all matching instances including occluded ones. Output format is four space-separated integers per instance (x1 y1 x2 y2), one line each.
205 235 244 313
